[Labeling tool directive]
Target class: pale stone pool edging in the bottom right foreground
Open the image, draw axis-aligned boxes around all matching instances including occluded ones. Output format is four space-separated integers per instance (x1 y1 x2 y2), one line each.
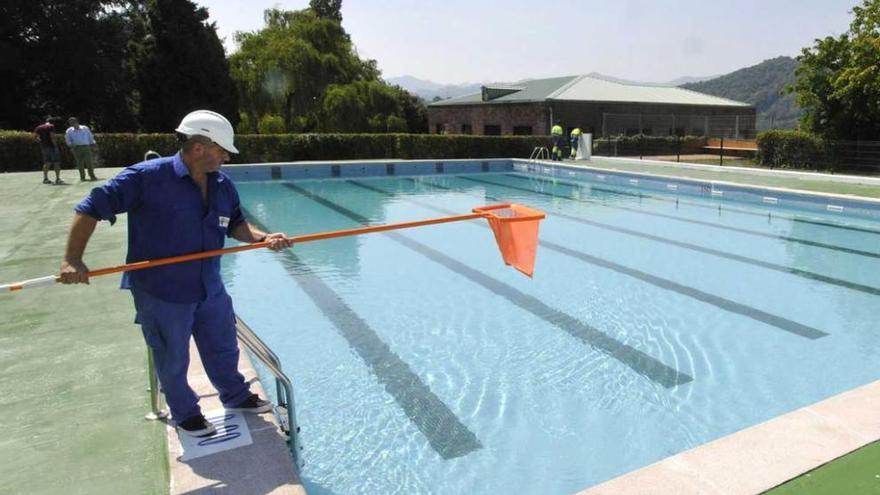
576 380 880 495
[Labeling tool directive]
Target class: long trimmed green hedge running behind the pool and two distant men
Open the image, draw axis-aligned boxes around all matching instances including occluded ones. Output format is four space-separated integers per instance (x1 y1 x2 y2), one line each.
0 131 550 172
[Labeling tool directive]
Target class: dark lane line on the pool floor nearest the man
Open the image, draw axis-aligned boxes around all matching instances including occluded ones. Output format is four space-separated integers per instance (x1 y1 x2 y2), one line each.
244 207 482 459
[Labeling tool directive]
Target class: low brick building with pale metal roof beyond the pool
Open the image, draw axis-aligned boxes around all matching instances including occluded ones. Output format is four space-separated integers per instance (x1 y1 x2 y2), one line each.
428 75 756 139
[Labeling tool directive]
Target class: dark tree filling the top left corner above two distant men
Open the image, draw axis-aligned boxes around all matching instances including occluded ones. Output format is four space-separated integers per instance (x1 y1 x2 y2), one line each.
0 0 137 130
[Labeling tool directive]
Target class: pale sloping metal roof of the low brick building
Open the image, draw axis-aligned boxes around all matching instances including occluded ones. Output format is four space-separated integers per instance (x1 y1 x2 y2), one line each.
428 76 751 108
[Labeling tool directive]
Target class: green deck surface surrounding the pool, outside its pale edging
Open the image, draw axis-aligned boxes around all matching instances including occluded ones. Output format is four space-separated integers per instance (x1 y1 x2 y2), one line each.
0 158 880 495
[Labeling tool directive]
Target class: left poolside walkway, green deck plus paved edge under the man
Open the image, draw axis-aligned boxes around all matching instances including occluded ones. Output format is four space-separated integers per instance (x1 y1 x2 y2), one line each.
0 169 305 495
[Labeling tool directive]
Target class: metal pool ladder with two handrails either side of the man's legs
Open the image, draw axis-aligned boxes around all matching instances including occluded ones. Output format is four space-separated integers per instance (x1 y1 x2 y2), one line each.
146 316 303 468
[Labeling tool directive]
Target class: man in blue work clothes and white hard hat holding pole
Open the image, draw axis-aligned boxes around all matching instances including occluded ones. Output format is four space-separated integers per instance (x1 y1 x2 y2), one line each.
61 110 292 436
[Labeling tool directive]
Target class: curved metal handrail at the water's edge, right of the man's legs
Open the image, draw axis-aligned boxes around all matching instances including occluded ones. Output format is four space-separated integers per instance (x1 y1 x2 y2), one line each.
235 316 302 467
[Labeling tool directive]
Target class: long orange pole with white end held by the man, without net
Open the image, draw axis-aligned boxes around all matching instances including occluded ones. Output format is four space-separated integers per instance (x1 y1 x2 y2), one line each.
0 209 488 292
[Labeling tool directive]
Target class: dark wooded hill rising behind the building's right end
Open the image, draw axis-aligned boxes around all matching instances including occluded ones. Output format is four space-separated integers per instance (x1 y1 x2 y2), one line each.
681 57 802 131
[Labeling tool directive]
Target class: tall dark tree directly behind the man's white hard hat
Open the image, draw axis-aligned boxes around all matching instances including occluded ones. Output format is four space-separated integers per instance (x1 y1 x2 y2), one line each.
134 0 238 132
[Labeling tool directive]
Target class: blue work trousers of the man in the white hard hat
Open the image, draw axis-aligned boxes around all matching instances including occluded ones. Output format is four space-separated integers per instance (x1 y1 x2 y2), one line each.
131 288 251 423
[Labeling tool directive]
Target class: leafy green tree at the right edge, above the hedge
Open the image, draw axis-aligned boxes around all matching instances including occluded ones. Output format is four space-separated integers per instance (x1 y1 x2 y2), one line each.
791 0 880 139
